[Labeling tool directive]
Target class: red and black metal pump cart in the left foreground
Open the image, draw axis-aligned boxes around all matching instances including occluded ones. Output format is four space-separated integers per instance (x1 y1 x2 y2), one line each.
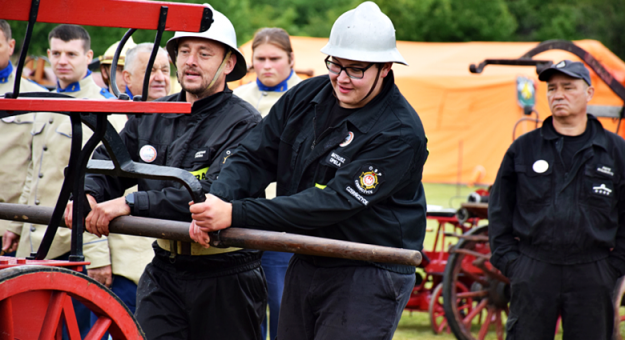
0 0 212 339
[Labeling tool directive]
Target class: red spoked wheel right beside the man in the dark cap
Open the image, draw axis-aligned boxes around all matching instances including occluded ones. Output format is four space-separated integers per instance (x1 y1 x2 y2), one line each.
443 226 510 340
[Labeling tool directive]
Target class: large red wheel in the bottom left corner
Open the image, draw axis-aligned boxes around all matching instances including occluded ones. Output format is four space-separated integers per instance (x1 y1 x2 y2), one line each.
0 265 145 340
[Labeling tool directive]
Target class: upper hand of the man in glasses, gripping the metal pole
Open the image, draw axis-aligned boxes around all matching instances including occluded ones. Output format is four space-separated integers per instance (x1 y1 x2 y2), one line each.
189 194 232 232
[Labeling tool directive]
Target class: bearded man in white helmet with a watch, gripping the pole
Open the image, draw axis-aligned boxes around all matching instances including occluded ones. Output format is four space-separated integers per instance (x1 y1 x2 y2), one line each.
65 5 267 340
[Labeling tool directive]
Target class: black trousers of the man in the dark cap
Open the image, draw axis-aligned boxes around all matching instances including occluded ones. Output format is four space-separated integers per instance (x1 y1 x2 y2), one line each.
506 255 618 340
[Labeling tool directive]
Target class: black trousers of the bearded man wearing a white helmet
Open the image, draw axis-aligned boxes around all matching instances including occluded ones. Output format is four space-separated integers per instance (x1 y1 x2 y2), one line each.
135 246 267 340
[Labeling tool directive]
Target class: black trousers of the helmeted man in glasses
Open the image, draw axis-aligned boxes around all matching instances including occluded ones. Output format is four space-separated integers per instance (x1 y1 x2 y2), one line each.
277 255 415 340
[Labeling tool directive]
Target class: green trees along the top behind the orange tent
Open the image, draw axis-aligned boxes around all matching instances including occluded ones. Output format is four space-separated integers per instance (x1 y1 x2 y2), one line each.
6 0 625 60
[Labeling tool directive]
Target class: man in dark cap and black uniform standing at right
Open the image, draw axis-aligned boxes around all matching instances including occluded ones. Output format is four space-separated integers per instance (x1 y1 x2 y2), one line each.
488 60 625 340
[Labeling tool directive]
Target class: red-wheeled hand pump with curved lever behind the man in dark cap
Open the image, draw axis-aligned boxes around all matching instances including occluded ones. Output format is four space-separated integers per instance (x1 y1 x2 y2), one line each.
443 40 625 340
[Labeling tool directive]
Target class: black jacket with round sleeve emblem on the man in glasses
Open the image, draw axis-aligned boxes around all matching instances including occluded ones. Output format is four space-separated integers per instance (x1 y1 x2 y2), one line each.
211 73 428 273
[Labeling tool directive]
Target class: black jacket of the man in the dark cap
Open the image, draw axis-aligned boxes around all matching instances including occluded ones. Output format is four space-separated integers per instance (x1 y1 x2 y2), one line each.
488 115 625 274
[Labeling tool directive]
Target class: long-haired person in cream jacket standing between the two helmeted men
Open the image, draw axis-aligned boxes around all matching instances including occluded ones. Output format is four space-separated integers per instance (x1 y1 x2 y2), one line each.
234 28 302 339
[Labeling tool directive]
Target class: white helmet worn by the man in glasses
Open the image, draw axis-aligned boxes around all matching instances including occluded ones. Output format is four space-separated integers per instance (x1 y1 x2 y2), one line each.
321 1 408 65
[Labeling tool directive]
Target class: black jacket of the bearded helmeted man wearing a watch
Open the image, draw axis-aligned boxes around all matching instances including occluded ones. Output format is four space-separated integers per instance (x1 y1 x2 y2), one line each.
85 88 261 221
